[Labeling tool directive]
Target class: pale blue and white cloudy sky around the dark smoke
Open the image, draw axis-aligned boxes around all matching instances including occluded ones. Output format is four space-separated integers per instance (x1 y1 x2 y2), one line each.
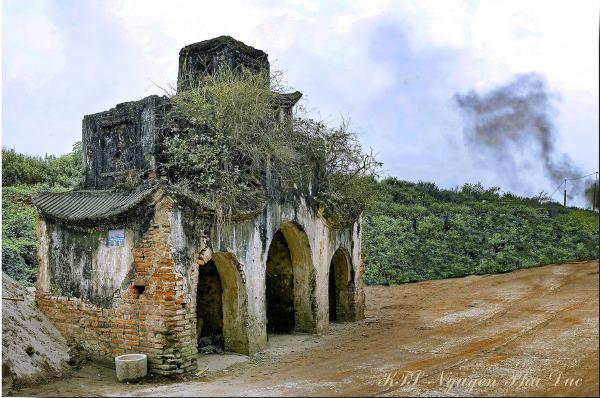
2 0 599 205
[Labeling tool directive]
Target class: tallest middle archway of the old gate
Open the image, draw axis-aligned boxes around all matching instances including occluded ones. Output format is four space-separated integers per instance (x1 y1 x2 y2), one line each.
265 222 316 333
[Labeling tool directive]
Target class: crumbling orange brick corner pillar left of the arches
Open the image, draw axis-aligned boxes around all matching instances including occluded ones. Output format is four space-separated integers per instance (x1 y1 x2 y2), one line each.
127 197 198 375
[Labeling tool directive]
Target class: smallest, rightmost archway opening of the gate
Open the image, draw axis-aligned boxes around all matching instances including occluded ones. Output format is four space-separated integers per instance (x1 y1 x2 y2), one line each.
328 248 354 322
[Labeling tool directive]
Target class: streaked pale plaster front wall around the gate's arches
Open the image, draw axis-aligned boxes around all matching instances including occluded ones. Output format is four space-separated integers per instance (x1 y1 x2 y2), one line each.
208 197 364 352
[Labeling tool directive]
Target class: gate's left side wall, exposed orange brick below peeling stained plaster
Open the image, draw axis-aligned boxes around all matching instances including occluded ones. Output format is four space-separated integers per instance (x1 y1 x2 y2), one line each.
36 193 198 374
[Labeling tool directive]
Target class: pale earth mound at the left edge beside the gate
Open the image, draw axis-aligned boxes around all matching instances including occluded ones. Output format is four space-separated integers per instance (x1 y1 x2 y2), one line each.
2 272 71 394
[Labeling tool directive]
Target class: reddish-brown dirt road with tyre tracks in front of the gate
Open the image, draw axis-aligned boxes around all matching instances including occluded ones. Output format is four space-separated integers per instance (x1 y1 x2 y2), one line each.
19 261 598 396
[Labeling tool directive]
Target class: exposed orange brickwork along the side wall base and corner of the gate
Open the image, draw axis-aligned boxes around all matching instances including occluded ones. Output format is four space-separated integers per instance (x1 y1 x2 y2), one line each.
37 197 201 375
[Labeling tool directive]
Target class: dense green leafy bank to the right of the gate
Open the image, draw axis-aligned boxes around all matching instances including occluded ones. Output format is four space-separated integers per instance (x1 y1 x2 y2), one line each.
363 178 598 284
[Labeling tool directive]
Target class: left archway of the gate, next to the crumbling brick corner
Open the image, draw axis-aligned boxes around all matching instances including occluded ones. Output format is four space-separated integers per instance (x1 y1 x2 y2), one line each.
196 252 249 354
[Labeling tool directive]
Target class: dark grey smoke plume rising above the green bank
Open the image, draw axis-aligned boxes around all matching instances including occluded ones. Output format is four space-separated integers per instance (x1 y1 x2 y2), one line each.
454 73 582 202
